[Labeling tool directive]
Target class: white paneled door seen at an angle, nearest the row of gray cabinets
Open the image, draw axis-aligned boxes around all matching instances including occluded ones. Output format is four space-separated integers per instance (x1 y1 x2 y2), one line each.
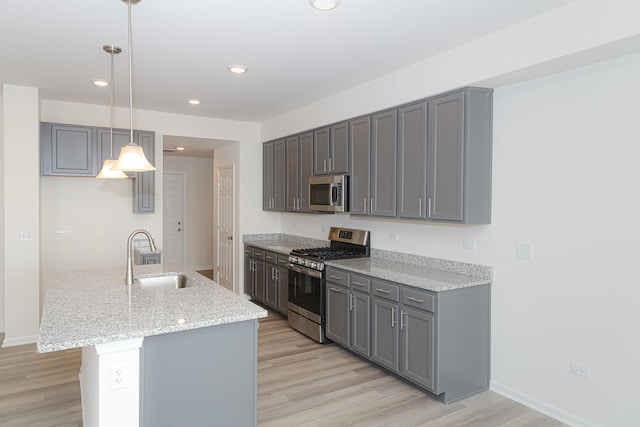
217 165 236 291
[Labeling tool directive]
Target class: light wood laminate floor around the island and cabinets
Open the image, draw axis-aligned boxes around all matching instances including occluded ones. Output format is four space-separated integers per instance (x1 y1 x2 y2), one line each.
0 313 563 427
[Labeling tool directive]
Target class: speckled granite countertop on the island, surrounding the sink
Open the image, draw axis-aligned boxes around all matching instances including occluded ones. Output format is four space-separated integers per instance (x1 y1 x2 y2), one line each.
37 264 267 353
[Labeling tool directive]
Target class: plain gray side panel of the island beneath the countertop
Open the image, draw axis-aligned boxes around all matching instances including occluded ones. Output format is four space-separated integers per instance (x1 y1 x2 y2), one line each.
140 320 258 427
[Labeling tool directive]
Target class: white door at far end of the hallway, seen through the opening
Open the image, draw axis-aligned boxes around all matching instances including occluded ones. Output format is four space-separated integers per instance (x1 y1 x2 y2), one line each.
162 173 184 264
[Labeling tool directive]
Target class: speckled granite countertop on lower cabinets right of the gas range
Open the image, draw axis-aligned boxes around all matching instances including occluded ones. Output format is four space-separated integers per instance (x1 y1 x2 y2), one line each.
325 258 491 292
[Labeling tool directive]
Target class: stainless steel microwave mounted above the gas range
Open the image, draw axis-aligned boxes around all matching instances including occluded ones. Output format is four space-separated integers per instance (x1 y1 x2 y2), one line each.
309 175 349 212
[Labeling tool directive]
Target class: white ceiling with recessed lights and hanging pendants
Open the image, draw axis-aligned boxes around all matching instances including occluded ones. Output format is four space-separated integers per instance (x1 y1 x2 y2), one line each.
0 0 569 122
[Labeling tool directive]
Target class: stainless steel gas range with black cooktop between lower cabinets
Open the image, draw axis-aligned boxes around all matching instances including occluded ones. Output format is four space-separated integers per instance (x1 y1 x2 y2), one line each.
289 227 371 343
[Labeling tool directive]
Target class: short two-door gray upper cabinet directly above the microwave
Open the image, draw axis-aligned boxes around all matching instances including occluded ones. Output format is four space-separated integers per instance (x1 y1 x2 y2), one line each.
313 122 349 175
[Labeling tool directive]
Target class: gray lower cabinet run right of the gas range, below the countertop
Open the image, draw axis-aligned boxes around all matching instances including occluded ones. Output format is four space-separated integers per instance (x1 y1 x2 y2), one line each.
327 267 490 403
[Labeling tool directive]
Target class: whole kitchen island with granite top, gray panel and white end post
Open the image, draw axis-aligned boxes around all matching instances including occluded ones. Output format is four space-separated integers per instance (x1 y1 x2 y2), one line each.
37 265 267 427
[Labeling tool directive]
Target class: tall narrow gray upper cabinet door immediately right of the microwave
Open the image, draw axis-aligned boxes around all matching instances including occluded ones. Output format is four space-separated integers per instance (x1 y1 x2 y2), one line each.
349 116 371 215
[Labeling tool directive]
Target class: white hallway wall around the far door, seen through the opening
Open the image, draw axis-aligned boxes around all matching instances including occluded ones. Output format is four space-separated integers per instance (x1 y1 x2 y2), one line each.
164 156 215 270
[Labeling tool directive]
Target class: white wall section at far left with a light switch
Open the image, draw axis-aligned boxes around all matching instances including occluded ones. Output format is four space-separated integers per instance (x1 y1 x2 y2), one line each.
2 85 40 346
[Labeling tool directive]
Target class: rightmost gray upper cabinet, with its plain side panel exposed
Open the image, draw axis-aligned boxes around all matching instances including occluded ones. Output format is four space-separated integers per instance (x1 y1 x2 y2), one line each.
427 88 493 224
